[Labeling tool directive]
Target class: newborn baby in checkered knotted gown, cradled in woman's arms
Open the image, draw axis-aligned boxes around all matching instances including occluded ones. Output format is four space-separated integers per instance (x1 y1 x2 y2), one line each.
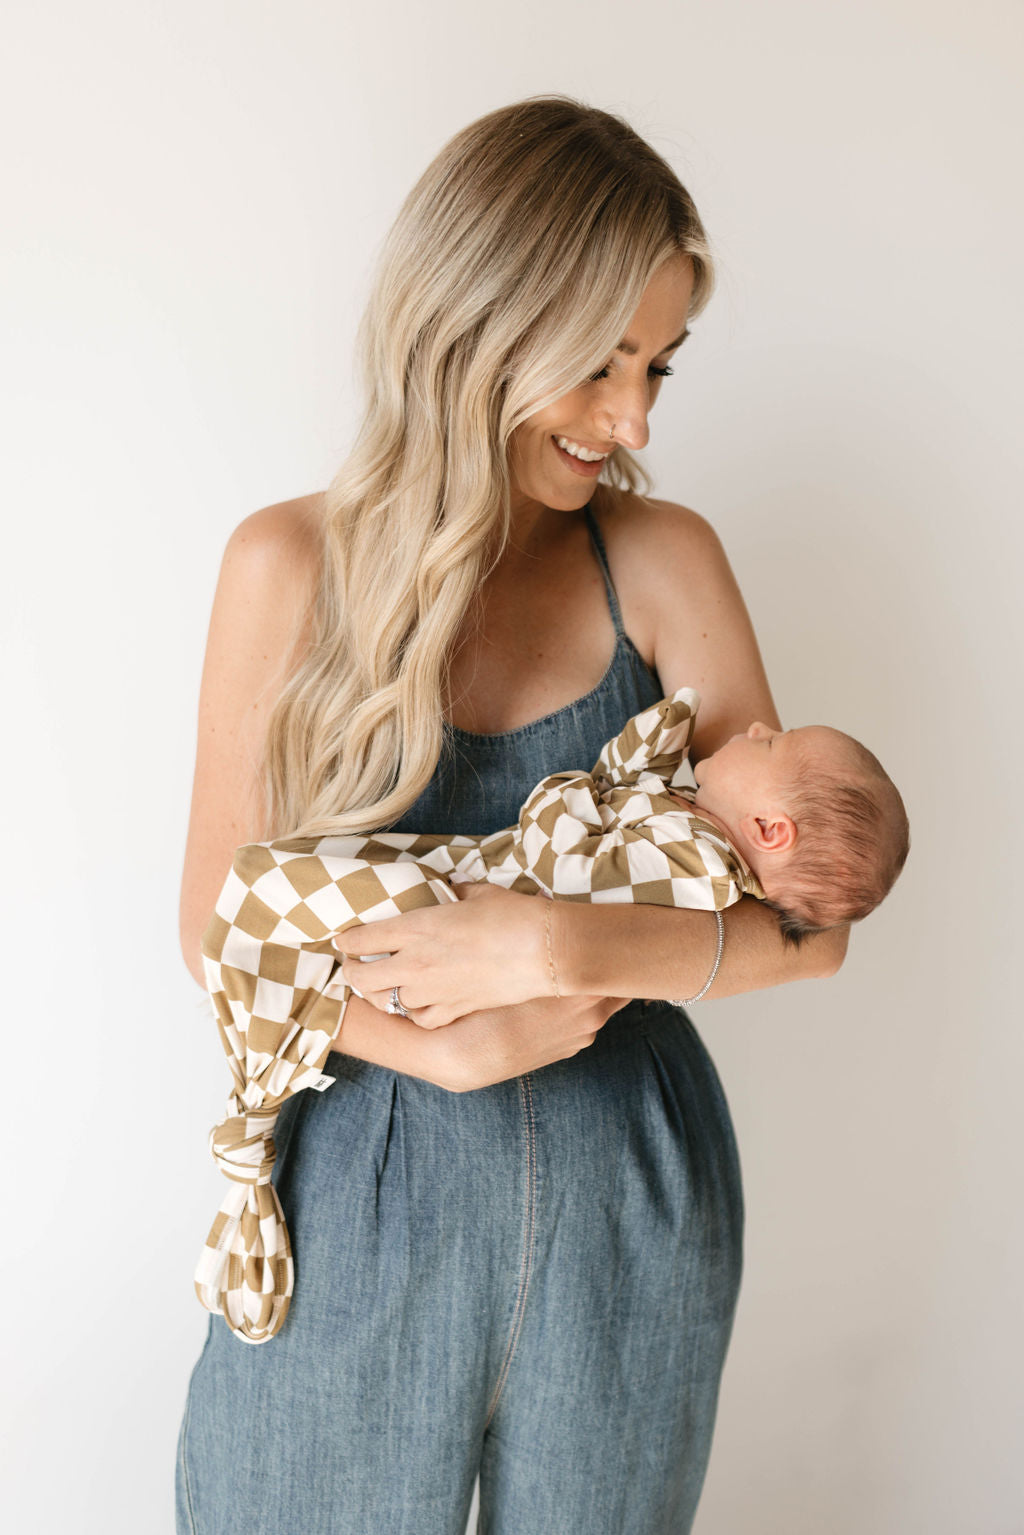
195 688 907 1343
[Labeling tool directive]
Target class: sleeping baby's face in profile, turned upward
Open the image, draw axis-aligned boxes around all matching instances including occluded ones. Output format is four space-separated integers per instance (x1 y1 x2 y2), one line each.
694 720 844 826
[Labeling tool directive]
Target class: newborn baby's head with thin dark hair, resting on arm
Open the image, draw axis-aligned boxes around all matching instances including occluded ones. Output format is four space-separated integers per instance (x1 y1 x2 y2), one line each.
694 723 910 942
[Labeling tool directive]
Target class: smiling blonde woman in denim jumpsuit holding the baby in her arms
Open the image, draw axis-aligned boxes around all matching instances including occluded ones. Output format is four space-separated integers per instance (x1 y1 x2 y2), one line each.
178 98 844 1535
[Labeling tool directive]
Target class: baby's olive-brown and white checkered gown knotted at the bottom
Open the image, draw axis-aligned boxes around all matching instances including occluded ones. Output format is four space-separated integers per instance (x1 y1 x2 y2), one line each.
195 688 763 1343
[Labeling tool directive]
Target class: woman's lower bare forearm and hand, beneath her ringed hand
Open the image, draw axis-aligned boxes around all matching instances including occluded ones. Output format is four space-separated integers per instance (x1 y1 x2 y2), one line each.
333 996 625 1093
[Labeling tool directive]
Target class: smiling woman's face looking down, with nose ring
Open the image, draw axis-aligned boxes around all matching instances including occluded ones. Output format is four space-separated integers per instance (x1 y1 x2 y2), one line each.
508 255 694 513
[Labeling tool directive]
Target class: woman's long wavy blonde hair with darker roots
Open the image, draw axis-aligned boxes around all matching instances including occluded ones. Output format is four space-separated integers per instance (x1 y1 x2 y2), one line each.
264 97 712 837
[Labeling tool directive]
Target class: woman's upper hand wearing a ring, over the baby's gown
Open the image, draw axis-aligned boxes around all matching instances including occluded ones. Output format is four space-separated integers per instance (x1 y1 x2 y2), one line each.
335 884 555 1025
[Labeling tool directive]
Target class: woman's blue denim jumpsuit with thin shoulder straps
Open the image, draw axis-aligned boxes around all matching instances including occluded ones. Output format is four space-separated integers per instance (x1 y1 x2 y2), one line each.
177 510 743 1535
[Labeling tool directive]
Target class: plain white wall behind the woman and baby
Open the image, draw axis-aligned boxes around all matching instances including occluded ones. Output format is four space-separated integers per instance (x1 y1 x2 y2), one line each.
0 0 1024 1535
